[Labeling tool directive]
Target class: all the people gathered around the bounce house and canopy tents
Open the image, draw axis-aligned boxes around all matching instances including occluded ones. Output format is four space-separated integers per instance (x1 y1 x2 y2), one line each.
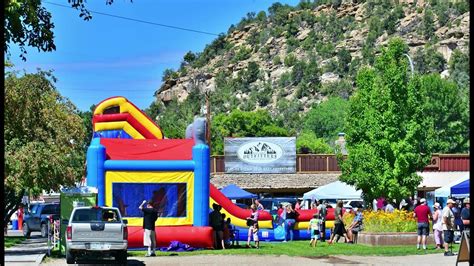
139 194 470 256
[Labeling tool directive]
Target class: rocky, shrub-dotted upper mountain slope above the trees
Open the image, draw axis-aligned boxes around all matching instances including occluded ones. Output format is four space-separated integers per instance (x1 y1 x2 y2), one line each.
155 1 469 112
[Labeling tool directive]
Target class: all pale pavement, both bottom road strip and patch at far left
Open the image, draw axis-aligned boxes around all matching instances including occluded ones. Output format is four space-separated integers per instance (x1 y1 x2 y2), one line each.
5 231 468 266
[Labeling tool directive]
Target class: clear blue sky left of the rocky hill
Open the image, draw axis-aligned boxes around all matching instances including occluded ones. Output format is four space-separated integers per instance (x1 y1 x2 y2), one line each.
9 0 299 111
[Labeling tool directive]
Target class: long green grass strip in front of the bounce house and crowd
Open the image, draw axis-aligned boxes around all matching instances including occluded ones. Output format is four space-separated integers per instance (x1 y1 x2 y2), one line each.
128 240 459 257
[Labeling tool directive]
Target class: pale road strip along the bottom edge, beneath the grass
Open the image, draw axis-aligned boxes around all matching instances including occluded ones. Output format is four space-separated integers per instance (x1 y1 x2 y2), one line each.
41 254 468 266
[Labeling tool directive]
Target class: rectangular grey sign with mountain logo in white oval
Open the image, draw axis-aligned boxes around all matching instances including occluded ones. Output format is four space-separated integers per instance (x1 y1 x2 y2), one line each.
224 137 296 173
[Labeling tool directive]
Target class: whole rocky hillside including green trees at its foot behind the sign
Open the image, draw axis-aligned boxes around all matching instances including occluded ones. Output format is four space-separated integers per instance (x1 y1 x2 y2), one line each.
147 0 470 154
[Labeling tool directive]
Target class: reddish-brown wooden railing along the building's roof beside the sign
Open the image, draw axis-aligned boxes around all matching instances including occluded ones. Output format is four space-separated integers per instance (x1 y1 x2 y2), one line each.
211 154 469 173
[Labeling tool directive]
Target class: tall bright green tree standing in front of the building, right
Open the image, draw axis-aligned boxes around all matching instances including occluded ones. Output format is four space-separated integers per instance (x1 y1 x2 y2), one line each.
339 38 435 202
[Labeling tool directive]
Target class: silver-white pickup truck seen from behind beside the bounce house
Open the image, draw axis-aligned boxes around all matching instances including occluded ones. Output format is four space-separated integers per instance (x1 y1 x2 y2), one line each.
66 206 128 264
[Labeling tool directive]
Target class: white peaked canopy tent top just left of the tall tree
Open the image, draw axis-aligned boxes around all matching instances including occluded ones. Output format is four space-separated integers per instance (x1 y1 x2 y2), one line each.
303 181 362 200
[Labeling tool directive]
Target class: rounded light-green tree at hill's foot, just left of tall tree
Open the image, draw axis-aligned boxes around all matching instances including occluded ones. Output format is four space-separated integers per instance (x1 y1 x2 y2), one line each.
303 97 349 141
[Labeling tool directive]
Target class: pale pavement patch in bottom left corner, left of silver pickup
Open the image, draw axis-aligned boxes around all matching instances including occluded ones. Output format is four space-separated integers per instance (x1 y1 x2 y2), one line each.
5 230 48 266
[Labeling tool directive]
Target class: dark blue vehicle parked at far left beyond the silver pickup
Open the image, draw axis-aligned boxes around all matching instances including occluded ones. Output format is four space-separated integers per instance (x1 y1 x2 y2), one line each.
23 203 60 238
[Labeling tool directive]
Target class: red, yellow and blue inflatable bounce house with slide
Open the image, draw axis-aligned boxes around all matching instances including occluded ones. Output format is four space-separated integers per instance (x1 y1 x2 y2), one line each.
87 97 334 248
